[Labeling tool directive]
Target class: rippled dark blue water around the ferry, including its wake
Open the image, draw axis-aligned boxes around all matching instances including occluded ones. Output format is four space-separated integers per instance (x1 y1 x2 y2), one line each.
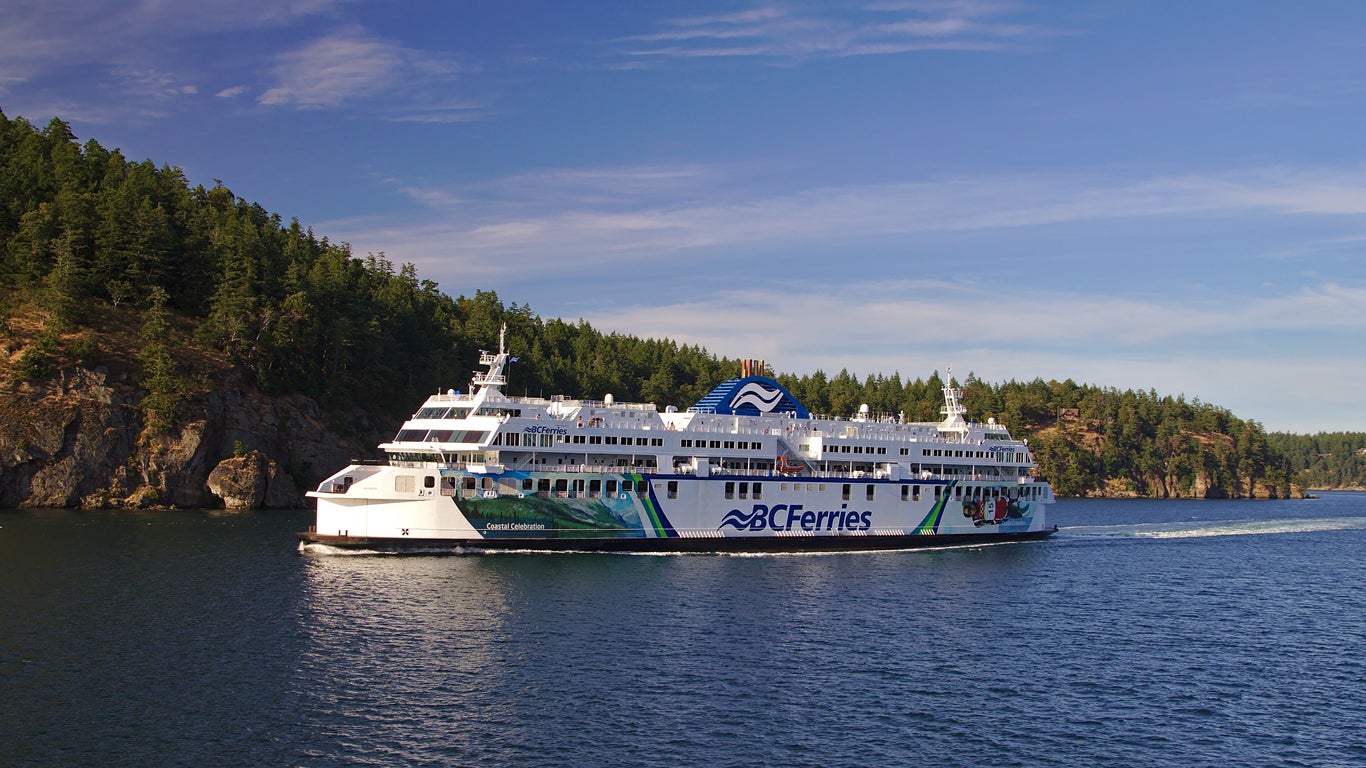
0 493 1366 767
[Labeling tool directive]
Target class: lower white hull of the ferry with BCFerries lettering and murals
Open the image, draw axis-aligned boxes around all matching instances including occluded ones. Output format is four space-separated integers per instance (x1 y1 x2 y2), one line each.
299 467 1053 552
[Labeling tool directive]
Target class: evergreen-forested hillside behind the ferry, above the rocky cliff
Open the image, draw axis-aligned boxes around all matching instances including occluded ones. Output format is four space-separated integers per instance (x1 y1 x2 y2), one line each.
0 115 1300 496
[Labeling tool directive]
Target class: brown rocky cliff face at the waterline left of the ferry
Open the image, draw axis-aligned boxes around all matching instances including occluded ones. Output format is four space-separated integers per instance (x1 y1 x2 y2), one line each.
0 368 382 508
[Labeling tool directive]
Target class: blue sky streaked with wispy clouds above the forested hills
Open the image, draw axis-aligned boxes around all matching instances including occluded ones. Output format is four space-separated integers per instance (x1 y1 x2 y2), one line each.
0 0 1366 432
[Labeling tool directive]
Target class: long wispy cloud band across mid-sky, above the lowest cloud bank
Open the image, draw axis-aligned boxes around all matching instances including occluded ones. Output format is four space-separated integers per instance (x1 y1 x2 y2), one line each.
331 167 1366 272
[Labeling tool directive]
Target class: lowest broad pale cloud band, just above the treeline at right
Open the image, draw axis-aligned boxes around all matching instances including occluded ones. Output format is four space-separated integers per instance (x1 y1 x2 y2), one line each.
585 280 1366 430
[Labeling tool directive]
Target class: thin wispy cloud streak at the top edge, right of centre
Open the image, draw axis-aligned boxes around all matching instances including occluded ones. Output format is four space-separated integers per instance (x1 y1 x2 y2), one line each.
619 0 1059 60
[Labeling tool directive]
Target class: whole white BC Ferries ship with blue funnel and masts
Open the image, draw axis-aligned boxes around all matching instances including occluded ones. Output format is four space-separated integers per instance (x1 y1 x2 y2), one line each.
298 323 1056 552
